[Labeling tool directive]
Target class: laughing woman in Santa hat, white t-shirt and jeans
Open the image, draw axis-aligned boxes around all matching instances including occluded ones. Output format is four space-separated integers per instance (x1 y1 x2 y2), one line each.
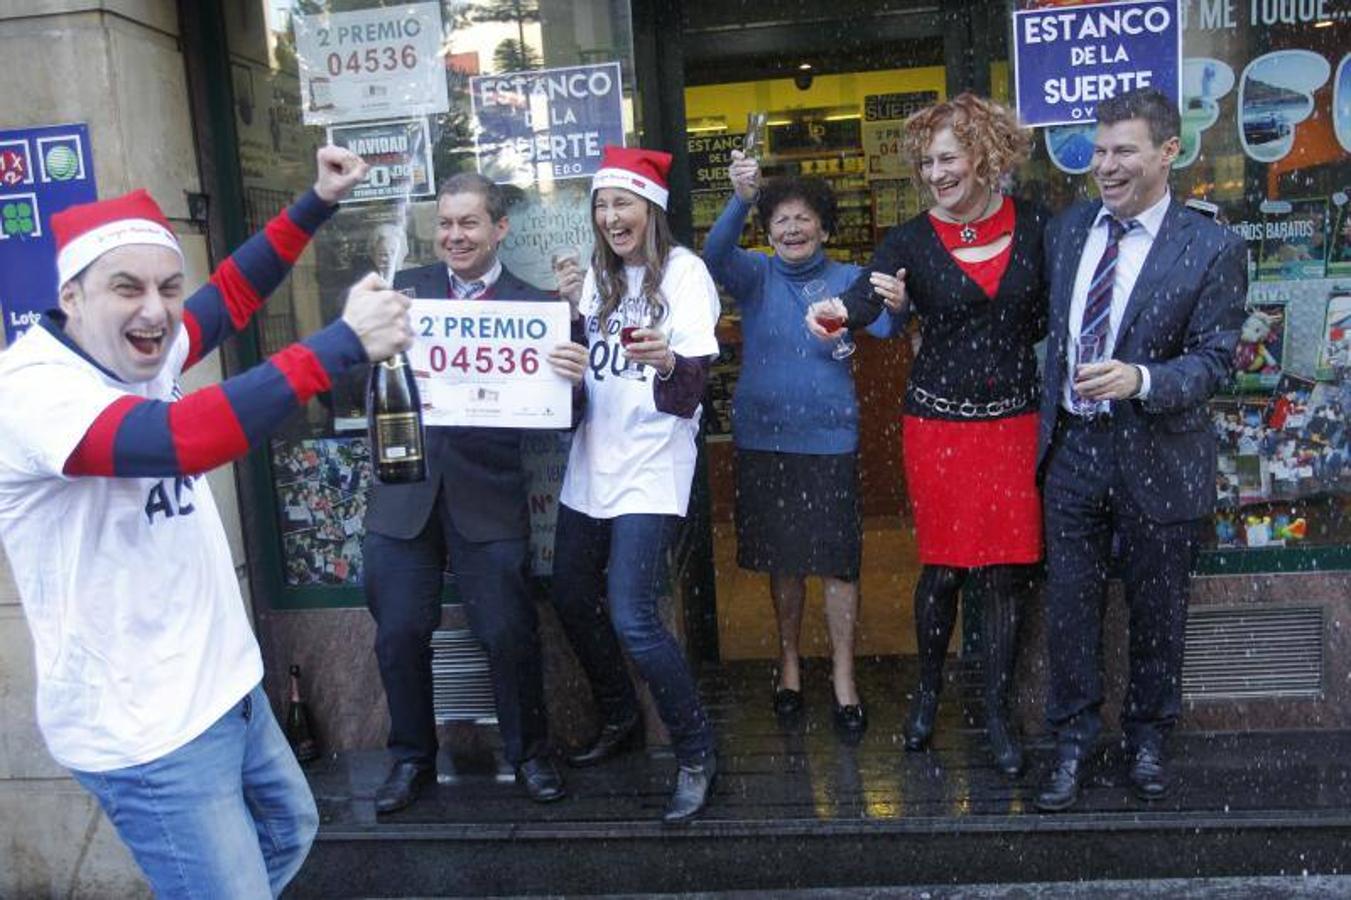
553 146 719 822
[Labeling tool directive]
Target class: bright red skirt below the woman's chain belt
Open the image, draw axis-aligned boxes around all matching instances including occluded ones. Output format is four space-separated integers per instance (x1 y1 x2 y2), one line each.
901 414 1042 569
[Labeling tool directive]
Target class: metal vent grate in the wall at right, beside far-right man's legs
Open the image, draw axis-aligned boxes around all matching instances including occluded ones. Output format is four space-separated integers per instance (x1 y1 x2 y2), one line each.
1182 607 1324 700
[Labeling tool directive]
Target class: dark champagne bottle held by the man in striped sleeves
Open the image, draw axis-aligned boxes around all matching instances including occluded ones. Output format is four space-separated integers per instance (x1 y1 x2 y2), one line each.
366 353 427 484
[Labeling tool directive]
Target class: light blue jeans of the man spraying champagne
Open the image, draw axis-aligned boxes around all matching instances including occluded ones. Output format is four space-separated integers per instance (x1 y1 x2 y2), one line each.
72 685 319 899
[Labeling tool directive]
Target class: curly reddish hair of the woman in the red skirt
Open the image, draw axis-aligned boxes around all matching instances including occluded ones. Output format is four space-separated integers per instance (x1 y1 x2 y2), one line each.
901 92 1032 188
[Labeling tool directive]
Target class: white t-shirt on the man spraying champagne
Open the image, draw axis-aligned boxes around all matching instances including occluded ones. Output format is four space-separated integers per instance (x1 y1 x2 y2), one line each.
0 326 262 772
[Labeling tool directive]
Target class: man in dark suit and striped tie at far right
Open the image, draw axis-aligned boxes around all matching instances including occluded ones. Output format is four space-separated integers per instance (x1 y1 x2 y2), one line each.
1036 88 1247 811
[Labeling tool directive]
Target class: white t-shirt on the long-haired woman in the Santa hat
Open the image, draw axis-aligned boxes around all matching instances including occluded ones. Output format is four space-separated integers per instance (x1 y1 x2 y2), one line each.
559 247 720 519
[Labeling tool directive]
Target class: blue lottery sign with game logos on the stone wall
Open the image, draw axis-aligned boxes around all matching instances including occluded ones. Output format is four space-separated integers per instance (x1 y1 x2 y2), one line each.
0 124 99 343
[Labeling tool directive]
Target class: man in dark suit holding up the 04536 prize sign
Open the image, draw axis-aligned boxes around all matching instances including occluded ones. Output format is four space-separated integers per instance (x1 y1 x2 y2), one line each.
363 173 586 812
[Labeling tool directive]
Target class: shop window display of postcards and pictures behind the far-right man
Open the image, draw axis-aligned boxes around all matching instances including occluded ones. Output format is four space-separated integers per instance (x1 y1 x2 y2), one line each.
1173 1 1351 549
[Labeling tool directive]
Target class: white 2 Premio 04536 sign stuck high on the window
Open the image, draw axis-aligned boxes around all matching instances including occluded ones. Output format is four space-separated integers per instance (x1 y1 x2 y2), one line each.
295 3 450 126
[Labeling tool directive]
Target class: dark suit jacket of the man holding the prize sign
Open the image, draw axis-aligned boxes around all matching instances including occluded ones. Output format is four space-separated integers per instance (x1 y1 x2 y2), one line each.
366 262 557 542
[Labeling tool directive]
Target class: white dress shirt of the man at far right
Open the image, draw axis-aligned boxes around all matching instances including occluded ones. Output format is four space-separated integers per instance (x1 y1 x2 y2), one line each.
1061 191 1173 412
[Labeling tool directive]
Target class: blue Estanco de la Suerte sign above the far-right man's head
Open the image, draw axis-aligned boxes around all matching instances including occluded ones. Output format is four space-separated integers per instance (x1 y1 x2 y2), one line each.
1013 0 1182 126
